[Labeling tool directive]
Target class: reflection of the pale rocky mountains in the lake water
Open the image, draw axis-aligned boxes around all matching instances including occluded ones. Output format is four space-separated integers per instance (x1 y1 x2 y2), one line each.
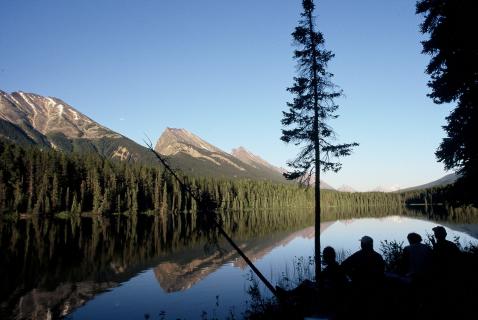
154 221 335 292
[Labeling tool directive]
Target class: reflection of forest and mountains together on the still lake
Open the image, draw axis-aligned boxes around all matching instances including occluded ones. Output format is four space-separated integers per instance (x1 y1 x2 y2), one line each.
0 207 476 318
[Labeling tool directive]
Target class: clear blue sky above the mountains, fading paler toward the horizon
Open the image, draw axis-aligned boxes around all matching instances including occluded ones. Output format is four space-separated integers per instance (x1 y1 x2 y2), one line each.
0 0 451 190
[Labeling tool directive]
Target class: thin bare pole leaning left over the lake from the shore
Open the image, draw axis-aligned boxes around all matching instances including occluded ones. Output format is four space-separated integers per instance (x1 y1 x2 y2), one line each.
144 138 279 298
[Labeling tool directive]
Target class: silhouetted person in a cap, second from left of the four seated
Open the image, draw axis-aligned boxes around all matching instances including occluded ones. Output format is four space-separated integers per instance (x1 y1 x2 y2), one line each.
342 236 385 289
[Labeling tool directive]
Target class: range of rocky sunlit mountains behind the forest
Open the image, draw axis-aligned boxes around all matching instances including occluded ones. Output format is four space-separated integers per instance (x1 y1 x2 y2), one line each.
0 90 457 192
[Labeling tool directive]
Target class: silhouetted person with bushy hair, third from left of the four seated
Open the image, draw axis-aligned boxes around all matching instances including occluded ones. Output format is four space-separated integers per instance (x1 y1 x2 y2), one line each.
402 232 432 283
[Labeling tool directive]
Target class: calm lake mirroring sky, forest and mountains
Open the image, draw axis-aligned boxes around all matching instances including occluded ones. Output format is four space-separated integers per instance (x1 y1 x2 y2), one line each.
0 209 478 319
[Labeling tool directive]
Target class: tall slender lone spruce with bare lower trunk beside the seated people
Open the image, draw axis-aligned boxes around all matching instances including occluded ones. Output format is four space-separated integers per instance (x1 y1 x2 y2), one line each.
281 0 358 277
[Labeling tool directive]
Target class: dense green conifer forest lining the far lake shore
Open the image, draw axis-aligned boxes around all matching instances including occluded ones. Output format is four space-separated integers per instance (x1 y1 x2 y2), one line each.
0 142 472 214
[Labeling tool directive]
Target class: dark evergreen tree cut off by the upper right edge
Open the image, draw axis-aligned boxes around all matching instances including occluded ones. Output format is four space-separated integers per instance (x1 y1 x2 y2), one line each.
416 0 478 204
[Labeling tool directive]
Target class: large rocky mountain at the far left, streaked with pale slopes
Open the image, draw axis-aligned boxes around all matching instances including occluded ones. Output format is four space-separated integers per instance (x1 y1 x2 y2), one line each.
0 91 156 162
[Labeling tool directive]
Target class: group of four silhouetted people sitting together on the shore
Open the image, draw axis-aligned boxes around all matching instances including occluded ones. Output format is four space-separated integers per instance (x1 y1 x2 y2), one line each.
282 226 460 317
